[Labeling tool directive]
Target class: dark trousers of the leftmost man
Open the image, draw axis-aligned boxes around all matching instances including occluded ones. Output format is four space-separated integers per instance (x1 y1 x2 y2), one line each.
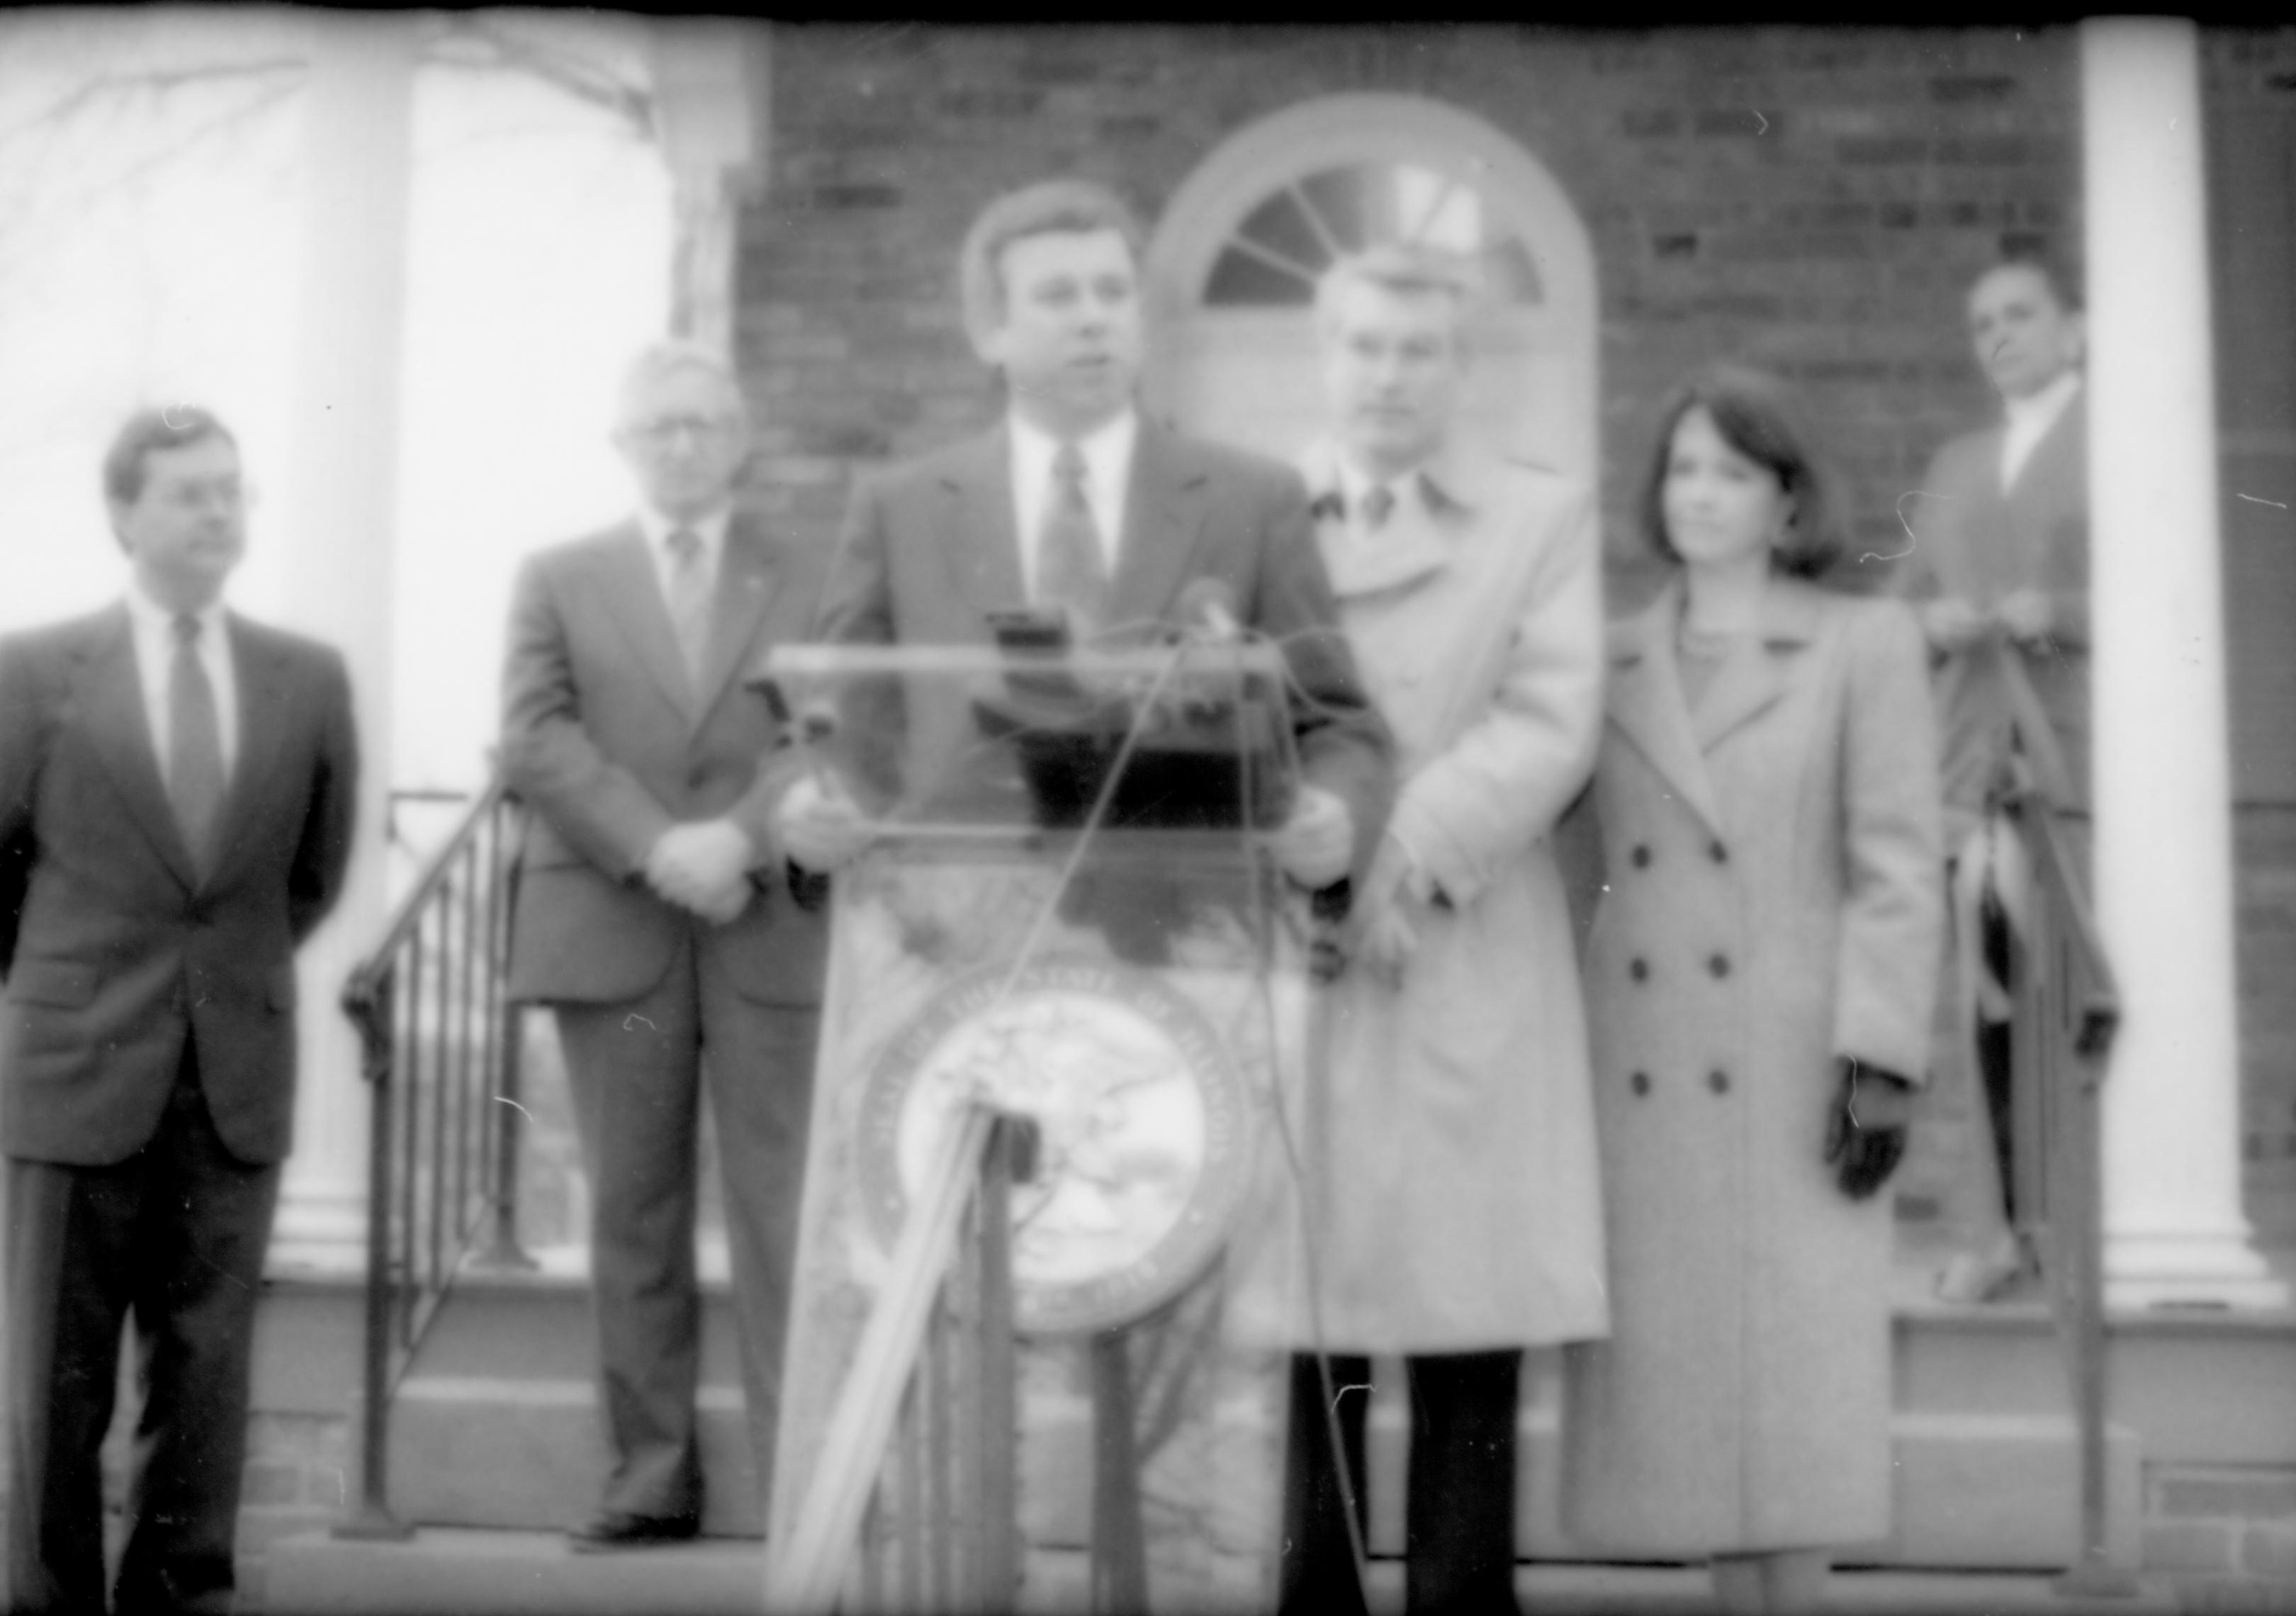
7 1040 280 1616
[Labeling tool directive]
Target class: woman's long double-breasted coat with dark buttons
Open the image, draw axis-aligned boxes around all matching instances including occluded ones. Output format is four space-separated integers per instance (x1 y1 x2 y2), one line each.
1563 578 1942 1556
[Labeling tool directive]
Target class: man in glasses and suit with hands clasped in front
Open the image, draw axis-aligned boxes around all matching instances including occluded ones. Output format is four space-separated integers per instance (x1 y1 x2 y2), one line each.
503 342 822 1552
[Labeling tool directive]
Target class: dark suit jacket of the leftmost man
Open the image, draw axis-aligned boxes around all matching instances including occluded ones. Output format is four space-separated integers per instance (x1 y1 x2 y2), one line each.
0 606 358 1166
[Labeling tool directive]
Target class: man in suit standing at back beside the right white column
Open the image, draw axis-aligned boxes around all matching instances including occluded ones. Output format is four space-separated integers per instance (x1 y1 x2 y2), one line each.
1896 259 2089 1301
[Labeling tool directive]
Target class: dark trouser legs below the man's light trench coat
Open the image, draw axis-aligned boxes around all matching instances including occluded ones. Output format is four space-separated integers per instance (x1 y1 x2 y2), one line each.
1281 1352 1522 1616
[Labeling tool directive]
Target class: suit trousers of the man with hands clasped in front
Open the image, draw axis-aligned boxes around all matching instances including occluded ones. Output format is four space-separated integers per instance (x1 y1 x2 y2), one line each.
556 927 820 1515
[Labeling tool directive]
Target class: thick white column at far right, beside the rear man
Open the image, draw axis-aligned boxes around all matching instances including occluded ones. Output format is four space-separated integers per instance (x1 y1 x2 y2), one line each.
2080 18 2287 1306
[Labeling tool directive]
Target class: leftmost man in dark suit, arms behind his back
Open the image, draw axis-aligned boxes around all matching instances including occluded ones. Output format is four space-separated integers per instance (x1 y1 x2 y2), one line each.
0 408 358 1614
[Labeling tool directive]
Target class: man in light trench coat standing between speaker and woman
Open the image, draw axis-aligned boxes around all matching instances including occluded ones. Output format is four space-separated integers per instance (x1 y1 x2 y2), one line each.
1283 248 1609 1612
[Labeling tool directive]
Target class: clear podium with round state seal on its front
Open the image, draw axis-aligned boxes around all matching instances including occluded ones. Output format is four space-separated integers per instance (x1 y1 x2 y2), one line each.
762 641 1311 1614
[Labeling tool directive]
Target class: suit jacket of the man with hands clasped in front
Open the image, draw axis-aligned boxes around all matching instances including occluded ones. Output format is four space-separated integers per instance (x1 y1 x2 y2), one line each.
503 514 824 1006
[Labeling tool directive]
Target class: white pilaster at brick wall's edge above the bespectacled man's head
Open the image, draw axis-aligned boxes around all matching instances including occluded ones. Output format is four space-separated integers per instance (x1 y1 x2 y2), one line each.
652 21 769 354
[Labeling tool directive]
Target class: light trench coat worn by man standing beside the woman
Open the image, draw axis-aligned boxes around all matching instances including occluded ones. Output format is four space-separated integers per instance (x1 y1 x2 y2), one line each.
1300 450 1607 1352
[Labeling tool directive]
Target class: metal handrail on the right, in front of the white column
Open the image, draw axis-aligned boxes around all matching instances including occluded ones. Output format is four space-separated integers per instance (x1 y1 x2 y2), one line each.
2005 663 2137 1598
